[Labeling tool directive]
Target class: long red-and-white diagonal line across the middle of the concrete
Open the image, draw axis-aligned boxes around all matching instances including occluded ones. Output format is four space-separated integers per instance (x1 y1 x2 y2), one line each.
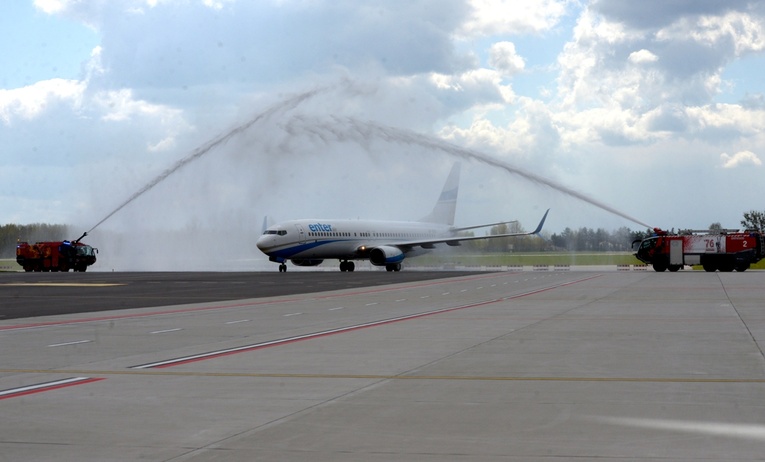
131 275 600 369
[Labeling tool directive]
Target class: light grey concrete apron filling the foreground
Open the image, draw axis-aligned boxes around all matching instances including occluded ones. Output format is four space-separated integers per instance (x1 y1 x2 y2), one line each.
0 271 765 462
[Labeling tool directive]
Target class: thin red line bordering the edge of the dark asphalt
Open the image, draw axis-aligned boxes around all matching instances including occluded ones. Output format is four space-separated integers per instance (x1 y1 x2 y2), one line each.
0 273 524 331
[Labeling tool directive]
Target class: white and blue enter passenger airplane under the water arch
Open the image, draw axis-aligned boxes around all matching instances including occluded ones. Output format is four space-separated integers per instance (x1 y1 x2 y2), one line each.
256 163 550 273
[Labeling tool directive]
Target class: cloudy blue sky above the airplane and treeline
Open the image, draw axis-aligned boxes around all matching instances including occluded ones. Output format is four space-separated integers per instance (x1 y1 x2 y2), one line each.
0 0 765 268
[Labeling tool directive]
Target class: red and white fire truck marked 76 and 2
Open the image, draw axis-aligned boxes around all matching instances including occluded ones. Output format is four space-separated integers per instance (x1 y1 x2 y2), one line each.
632 228 765 272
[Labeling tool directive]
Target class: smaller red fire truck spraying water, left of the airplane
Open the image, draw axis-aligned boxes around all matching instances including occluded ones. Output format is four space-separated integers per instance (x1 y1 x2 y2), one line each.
16 233 98 272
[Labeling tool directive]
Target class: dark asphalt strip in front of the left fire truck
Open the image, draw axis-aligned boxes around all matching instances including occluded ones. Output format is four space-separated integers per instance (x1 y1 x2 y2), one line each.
0 271 471 319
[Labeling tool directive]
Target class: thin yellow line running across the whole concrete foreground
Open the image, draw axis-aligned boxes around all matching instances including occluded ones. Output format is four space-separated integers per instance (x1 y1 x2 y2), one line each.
0 369 765 383
